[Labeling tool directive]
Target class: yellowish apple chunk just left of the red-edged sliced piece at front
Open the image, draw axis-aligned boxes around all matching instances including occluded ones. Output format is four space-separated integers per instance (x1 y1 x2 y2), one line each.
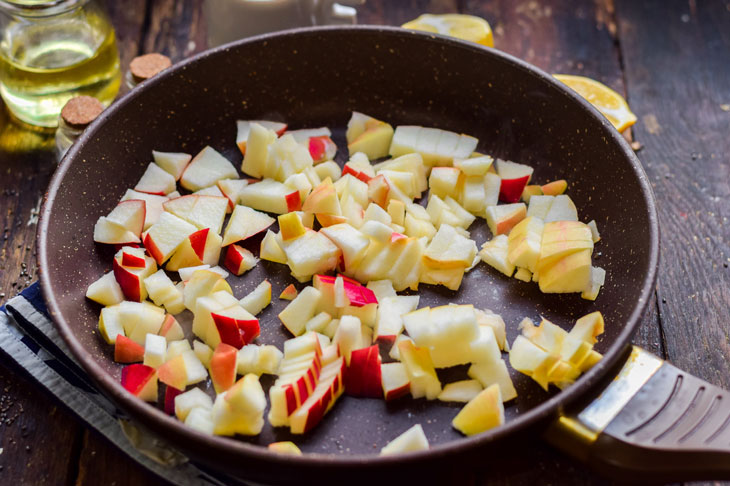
211 372 266 436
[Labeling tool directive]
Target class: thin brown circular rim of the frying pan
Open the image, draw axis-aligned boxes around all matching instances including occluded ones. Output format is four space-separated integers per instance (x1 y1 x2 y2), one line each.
36 25 659 467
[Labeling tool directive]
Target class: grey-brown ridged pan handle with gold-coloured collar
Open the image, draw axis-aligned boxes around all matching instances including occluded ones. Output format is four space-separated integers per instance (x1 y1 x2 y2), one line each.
546 346 730 481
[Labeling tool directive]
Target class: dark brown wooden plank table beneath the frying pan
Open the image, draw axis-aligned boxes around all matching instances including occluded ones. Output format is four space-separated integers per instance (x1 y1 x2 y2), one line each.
0 0 730 485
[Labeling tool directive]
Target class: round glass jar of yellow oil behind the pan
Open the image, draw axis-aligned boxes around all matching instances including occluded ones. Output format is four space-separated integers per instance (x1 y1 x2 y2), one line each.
0 0 121 127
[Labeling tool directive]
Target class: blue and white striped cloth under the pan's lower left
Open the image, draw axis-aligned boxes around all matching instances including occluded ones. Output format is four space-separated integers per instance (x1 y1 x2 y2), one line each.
0 282 253 486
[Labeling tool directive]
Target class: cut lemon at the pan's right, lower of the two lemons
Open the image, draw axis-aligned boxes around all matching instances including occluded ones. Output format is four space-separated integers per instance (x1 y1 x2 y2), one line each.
553 74 636 132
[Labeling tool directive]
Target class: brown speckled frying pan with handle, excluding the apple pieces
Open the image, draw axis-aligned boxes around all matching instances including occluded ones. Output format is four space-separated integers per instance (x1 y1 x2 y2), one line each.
38 26 730 484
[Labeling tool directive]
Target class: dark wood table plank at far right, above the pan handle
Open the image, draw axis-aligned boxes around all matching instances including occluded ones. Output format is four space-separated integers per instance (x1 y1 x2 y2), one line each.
616 0 730 388
